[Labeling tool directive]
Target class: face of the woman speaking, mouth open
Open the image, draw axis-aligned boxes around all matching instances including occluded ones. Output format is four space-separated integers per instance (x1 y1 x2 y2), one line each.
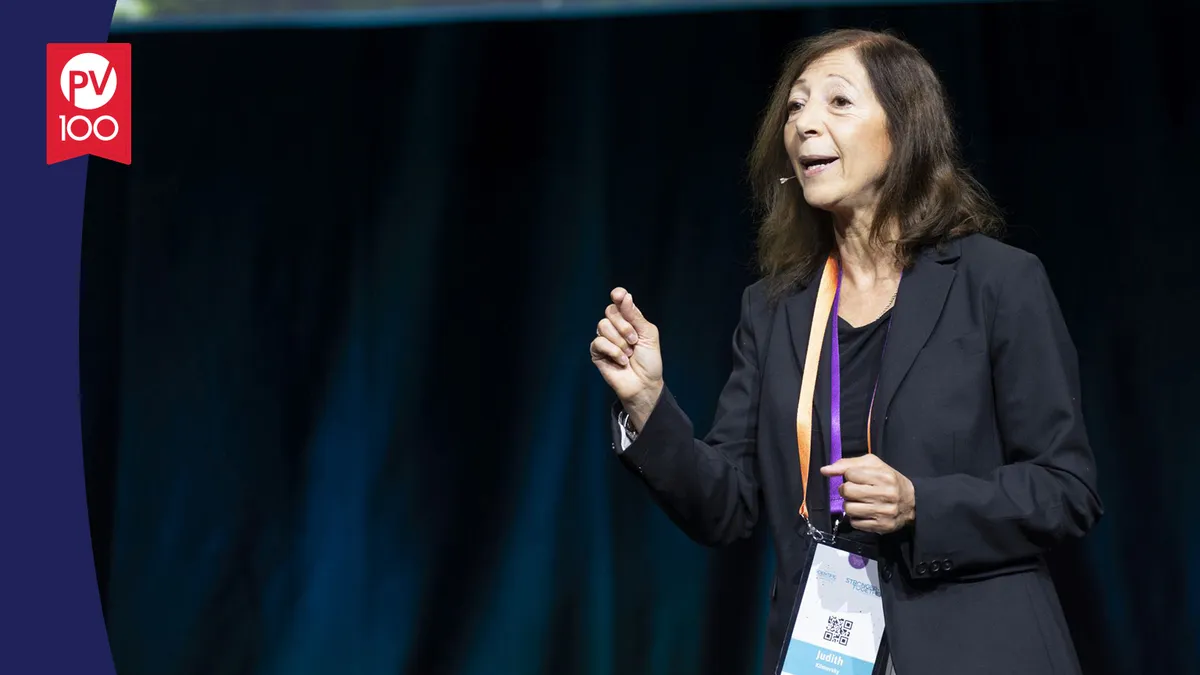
784 48 892 215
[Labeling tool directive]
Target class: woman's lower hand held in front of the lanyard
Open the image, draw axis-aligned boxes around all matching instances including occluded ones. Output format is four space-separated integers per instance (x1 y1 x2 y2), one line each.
821 454 917 534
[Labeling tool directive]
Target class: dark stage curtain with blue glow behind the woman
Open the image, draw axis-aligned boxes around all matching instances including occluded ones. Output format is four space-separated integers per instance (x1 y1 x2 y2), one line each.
80 2 1200 675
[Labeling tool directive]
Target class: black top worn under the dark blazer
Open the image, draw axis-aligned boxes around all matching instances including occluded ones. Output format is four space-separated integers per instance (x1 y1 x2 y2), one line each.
809 310 892 540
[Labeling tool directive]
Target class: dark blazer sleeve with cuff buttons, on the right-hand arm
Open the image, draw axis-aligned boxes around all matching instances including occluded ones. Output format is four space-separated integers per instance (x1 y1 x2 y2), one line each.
901 256 1103 578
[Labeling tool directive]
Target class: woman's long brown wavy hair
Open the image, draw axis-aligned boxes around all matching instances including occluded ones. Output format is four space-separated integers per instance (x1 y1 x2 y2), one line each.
750 29 1003 299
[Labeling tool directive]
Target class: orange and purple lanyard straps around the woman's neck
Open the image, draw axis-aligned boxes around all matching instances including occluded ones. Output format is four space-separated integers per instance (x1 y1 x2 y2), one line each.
796 256 904 527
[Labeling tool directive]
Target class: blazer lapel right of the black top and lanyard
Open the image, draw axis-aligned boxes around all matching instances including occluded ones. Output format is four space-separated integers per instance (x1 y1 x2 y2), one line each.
868 241 959 456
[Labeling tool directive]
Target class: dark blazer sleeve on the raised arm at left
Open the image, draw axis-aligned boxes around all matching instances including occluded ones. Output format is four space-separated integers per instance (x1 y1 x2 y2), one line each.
611 281 760 546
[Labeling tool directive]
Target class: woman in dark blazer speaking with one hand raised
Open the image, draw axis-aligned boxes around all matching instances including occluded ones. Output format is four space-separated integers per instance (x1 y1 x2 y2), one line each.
590 30 1102 675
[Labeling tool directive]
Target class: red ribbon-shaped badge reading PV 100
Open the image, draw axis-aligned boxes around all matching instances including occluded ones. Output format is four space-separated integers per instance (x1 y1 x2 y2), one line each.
46 43 133 165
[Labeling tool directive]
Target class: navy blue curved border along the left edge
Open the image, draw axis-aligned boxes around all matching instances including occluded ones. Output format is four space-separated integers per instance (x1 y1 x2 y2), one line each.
0 0 119 675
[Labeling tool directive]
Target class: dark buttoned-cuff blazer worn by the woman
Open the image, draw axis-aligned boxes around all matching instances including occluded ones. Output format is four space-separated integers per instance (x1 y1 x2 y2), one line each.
612 235 1102 675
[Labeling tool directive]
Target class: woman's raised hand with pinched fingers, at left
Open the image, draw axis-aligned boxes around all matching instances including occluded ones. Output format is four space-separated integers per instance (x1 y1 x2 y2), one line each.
592 287 662 430
